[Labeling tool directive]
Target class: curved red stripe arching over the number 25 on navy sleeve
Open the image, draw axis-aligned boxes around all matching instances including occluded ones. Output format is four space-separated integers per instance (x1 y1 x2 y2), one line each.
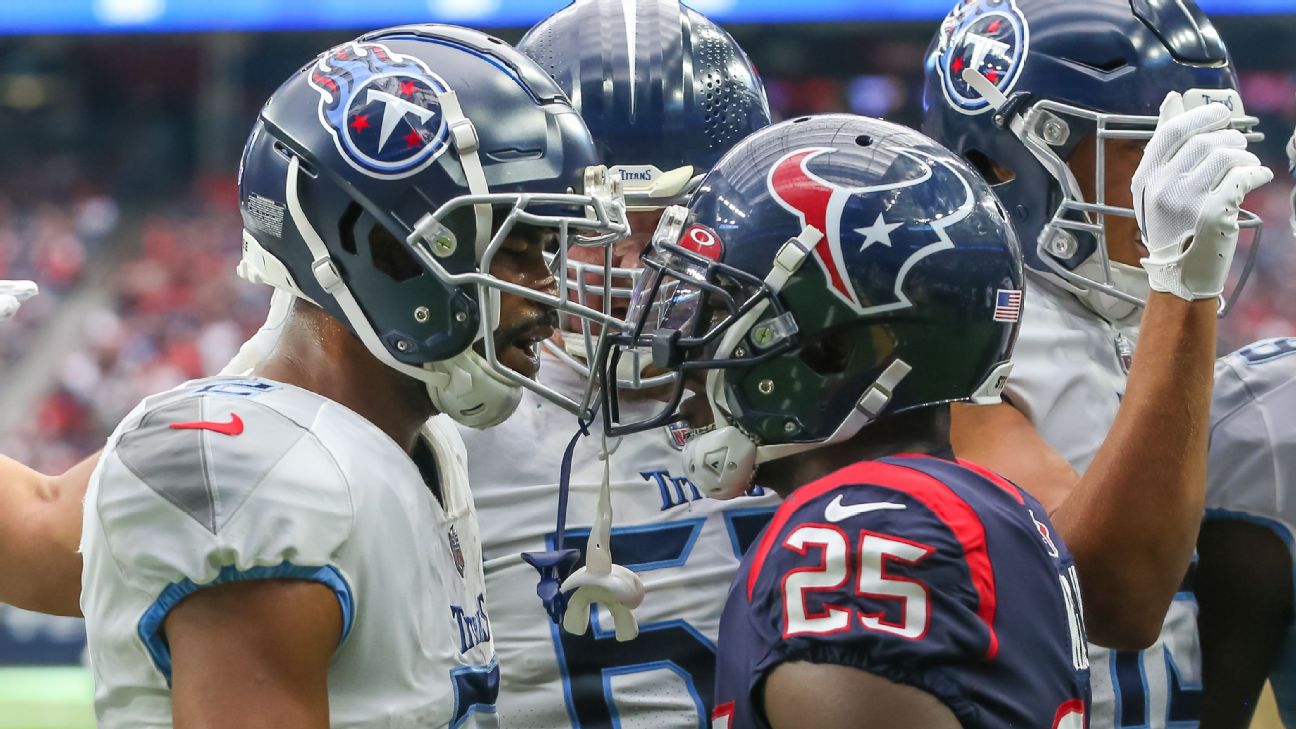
746 460 999 660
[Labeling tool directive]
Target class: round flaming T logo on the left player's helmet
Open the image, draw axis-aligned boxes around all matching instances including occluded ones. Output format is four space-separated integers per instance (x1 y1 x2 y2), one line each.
310 43 450 179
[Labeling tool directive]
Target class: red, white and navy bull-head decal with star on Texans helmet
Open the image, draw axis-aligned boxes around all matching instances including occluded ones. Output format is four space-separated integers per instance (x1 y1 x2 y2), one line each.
767 148 975 314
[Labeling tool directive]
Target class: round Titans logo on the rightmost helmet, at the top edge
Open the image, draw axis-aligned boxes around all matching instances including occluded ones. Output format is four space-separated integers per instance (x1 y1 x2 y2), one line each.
928 0 1030 114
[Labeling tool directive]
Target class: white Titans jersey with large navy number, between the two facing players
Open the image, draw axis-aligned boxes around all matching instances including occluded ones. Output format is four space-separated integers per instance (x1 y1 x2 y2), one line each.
463 357 778 729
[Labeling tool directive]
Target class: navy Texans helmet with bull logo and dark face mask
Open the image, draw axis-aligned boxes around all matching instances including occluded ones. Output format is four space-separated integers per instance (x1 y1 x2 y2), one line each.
600 114 1023 498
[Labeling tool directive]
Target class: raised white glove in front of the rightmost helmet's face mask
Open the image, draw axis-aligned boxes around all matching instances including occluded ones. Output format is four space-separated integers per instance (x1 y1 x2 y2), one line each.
1131 92 1274 301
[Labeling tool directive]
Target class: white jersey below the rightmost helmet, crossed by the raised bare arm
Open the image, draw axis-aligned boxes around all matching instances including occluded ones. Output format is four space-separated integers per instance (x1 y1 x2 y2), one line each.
1004 275 1201 729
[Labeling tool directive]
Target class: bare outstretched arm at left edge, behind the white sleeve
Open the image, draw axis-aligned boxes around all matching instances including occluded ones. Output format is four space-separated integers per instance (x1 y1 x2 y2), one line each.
0 453 98 616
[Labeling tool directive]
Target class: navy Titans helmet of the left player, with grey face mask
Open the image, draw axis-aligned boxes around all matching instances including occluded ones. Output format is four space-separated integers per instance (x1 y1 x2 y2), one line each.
238 25 626 427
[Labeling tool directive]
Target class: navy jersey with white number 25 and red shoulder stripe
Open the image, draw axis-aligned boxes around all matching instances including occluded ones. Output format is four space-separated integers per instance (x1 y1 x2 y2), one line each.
713 457 1089 729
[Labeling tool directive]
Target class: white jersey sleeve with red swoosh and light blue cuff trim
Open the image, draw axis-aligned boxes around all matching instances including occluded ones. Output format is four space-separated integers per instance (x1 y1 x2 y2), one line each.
82 388 355 678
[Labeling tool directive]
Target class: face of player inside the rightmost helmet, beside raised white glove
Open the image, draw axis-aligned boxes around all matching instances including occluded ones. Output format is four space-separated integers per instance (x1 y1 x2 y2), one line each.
1068 135 1147 266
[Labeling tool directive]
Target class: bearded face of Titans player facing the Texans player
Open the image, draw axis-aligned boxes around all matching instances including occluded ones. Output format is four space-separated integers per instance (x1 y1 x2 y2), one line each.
477 224 554 379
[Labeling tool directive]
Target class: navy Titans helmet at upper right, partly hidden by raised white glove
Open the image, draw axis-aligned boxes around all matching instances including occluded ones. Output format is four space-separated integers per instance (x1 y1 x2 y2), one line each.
923 0 1262 320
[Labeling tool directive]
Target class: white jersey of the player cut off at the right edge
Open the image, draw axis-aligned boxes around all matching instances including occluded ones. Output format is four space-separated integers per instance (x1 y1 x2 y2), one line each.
1207 337 1296 726
